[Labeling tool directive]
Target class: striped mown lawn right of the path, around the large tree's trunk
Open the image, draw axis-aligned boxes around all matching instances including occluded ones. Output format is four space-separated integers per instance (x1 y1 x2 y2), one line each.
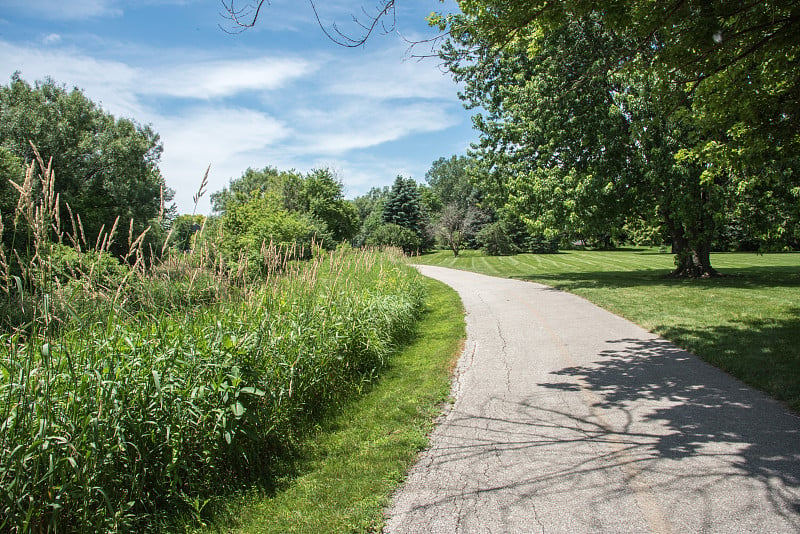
415 249 800 412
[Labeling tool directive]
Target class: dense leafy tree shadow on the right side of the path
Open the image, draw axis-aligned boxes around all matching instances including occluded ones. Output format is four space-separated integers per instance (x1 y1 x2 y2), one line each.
540 339 800 528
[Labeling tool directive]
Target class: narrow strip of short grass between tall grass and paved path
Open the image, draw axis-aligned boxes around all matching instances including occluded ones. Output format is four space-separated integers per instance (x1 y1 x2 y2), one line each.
203 279 465 534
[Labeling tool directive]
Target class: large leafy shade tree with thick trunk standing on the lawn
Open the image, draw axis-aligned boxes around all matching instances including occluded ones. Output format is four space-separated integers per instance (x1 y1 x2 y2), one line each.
432 0 800 276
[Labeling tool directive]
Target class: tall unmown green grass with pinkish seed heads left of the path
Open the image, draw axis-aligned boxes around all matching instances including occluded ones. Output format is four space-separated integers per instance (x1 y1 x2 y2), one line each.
0 149 423 532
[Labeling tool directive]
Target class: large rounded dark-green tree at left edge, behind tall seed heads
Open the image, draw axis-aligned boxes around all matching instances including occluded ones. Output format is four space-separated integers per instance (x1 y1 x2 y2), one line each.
0 74 174 260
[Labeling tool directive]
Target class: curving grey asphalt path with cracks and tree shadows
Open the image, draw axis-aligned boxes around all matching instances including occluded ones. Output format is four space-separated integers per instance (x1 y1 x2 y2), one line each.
385 267 800 534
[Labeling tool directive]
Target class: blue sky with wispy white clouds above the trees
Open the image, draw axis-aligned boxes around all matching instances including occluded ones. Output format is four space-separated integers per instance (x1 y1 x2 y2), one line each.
0 0 476 213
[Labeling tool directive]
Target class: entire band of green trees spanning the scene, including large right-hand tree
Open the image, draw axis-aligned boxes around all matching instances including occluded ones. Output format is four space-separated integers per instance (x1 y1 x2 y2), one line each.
0 0 800 276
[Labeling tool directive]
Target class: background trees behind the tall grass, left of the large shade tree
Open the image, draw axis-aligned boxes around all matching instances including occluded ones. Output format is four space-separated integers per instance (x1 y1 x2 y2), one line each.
0 73 488 271
